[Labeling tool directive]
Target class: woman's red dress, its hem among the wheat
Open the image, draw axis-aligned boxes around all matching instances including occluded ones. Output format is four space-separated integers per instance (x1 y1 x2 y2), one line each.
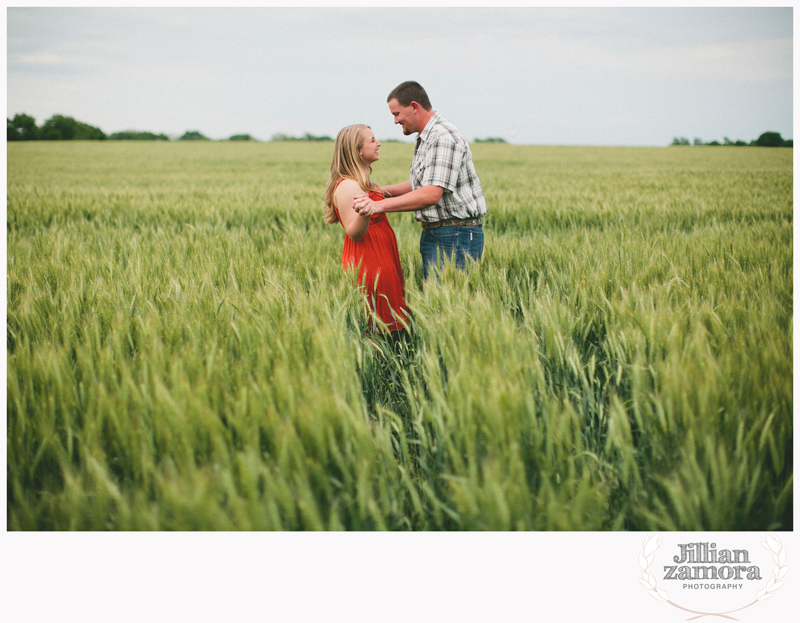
333 184 406 331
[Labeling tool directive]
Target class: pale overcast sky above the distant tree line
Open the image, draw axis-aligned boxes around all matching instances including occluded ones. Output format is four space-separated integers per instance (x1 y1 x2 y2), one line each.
7 7 793 145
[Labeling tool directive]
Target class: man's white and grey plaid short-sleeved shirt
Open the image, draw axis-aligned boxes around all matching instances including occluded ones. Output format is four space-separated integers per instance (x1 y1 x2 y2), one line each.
410 112 486 223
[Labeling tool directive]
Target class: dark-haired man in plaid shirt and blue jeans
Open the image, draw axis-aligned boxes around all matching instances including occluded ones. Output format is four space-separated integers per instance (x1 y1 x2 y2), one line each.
353 81 486 278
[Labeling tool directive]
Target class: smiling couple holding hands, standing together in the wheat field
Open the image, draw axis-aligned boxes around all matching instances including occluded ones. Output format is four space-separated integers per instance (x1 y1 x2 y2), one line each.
325 82 486 337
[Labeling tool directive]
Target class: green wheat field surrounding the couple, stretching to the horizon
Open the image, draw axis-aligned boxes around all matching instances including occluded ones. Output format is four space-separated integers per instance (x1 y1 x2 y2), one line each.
6 142 793 531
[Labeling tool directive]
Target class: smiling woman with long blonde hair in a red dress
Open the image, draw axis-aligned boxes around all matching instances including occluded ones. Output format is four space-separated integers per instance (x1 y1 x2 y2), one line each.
324 124 407 338
